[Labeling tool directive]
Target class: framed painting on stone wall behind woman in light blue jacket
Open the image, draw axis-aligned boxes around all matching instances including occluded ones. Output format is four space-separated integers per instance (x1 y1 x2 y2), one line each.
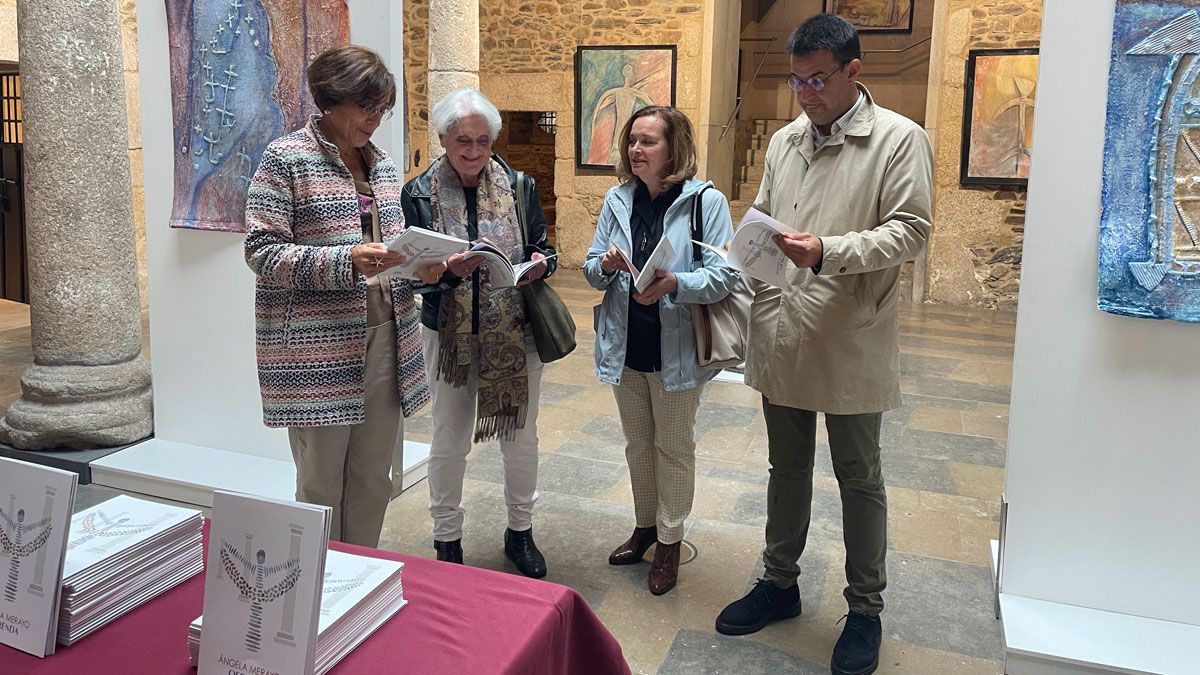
575 46 676 168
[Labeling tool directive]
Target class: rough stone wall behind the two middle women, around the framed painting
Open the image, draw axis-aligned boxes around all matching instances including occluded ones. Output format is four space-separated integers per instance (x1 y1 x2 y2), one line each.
404 0 736 268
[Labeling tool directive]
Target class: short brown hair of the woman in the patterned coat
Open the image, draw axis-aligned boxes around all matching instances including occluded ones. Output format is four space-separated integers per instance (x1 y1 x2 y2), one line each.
308 44 396 110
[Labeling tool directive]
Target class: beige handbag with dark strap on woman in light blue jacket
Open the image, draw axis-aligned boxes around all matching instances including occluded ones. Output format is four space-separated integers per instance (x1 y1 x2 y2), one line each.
690 187 754 369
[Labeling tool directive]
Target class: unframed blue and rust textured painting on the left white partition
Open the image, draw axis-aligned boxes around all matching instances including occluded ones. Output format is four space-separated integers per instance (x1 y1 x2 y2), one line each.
166 0 349 232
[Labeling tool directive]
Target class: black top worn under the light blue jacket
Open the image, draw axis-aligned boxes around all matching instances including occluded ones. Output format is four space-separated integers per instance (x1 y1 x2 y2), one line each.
625 179 683 372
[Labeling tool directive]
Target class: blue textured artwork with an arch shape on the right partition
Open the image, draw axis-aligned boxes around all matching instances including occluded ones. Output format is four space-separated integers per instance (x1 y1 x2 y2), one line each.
1098 0 1200 323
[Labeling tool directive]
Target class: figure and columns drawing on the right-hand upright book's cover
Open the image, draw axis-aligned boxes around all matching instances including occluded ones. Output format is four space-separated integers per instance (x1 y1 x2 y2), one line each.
221 525 304 652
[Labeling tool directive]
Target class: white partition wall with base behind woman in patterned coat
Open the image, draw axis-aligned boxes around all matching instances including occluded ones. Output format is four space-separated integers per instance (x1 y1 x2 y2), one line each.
92 0 428 506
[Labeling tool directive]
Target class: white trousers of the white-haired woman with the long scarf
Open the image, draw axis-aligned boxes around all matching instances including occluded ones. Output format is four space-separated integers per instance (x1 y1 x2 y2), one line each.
421 325 544 542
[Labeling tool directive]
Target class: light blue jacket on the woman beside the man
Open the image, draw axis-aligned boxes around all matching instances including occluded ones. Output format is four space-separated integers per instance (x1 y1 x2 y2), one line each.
583 178 738 392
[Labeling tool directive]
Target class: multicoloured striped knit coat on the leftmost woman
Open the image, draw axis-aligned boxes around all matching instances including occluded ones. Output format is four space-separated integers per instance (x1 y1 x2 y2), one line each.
246 118 430 426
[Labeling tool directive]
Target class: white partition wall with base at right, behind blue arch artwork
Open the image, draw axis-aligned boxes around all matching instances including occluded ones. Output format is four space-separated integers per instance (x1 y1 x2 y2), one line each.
1000 0 1200 675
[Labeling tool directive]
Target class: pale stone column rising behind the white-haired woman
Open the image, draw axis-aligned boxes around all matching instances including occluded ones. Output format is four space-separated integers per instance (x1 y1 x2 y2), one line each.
426 0 479 157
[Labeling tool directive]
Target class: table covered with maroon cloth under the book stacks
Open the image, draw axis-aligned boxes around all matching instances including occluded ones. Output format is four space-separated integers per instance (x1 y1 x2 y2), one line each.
0 524 629 675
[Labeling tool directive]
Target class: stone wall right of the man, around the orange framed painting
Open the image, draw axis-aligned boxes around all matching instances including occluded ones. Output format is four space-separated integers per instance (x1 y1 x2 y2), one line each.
924 0 1042 309
